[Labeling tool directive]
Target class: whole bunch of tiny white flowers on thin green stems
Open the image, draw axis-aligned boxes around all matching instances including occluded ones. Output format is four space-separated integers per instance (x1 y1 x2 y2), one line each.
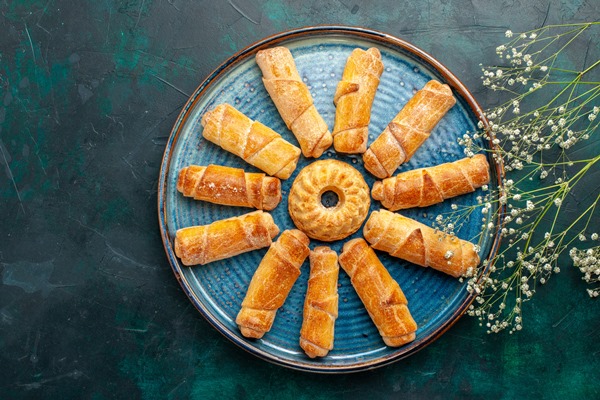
452 22 600 333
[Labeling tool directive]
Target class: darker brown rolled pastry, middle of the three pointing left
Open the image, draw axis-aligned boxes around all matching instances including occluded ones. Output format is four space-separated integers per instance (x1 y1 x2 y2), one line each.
177 165 281 210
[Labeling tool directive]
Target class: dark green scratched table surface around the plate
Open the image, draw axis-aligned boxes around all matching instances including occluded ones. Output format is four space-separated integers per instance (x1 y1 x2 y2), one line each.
0 0 600 399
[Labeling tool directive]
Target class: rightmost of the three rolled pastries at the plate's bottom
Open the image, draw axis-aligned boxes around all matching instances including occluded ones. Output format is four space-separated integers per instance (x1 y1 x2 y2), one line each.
340 238 417 347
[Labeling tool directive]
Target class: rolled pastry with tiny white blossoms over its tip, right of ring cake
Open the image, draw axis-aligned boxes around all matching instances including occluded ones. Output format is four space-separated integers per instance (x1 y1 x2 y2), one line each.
363 210 479 277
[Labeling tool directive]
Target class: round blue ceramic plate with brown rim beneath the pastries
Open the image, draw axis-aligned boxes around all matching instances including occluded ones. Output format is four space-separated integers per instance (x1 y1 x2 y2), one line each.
158 27 499 372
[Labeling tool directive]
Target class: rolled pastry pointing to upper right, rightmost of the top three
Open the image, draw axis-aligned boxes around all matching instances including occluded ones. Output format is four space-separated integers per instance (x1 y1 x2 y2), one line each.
363 80 456 179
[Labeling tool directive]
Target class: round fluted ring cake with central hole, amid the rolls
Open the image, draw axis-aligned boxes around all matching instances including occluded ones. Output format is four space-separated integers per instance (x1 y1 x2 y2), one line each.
288 160 371 242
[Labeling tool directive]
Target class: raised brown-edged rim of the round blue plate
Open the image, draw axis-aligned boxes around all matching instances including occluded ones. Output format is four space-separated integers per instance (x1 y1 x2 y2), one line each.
157 25 504 374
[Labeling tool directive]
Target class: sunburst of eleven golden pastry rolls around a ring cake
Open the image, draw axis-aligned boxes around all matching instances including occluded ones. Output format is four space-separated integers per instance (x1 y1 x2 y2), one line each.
174 43 490 358
